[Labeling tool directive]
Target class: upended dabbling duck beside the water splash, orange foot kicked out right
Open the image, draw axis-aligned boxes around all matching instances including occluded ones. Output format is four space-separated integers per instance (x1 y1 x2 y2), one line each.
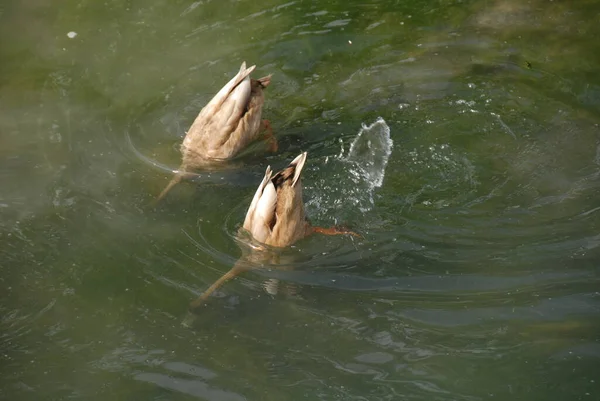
190 152 360 311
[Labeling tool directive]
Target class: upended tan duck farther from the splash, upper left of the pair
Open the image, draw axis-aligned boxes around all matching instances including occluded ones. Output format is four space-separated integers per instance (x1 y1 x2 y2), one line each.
156 61 277 202
